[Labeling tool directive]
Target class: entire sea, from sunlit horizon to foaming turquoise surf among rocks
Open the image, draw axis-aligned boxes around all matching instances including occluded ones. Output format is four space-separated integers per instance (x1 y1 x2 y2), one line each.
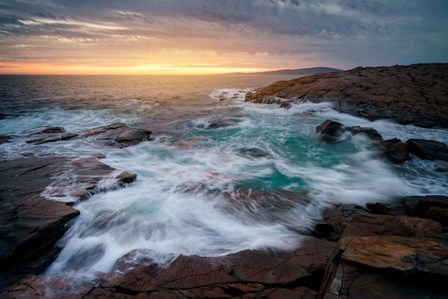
0 76 448 277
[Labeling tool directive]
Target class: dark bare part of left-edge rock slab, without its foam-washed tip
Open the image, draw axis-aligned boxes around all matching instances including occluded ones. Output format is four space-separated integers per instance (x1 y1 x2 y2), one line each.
0 158 79 289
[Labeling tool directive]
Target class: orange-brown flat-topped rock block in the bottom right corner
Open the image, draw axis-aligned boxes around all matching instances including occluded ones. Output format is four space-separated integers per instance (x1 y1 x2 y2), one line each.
320 236 448 298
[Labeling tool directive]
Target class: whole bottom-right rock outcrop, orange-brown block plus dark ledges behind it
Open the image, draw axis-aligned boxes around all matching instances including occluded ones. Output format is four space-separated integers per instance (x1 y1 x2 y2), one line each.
316 196 448 298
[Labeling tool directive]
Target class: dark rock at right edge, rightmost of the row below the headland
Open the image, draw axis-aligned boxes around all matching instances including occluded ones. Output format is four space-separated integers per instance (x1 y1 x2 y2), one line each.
406 139 448 161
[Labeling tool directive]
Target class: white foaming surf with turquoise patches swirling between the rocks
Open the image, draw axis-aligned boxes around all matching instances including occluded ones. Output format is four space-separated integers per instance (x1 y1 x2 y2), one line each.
49 96 446 282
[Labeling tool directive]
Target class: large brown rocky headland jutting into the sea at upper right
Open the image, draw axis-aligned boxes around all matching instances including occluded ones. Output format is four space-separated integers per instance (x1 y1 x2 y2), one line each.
246 64 448 128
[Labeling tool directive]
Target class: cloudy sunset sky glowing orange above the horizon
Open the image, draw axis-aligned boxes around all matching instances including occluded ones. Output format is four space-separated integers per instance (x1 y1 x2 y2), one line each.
0 0 448 74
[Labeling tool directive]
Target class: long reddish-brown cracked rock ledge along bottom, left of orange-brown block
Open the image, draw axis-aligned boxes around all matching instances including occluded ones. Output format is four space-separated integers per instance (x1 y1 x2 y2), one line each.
4 238 337 298
